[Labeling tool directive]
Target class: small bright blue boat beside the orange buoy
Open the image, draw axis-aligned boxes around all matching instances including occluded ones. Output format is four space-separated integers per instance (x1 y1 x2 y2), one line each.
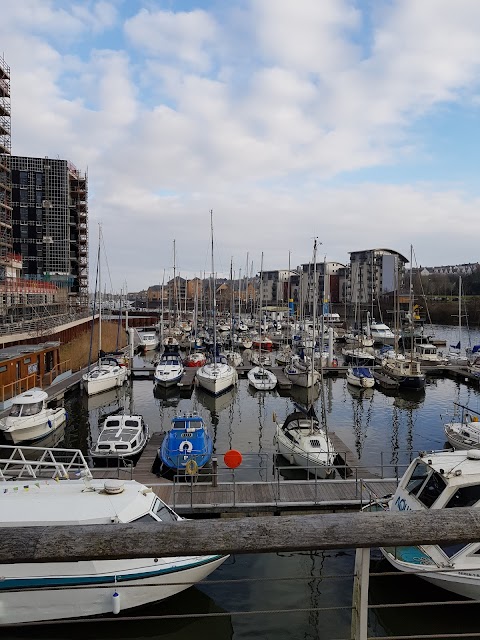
158 414 213 471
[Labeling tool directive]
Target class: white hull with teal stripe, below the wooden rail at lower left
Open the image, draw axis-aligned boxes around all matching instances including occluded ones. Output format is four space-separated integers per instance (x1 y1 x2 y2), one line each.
0 556 227 624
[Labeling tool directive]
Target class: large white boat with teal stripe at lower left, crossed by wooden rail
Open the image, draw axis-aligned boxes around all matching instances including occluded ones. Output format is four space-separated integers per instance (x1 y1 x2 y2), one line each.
0 445 227 625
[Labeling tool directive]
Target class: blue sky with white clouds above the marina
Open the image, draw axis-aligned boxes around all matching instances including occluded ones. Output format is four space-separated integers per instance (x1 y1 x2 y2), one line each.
0 0 480 292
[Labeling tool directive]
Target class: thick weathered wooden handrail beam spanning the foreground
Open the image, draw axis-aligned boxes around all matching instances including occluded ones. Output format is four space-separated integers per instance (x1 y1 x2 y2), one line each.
0 508 480 563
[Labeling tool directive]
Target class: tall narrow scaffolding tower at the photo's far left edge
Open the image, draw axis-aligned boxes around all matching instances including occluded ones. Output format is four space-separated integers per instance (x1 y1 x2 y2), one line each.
0 56 12 268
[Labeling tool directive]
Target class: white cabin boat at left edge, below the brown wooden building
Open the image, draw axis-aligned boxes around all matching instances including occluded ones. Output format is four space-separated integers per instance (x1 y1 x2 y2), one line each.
0 387 67 444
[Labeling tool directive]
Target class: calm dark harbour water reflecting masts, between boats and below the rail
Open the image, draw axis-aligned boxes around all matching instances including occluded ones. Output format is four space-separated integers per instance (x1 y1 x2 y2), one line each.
2 327 480 640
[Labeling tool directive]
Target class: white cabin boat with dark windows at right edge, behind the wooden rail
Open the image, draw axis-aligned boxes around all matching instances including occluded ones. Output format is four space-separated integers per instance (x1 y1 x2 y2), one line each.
365 449 480 600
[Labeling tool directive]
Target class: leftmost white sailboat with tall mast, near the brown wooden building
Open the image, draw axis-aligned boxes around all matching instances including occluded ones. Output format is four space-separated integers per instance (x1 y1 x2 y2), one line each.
82 227 128 396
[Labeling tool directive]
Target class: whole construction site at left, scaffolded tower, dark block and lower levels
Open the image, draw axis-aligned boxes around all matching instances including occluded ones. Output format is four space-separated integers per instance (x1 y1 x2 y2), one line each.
0 57 88 339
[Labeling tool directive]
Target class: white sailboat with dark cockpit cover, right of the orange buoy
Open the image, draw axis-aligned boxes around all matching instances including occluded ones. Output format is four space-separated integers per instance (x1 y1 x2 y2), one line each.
273 404 336 478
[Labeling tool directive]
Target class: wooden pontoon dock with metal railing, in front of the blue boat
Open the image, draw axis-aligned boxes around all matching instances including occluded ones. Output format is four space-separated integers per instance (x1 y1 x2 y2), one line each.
89 432 397 516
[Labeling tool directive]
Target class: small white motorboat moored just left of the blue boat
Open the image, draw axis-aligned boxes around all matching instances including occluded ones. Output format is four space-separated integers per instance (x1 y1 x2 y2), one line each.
90 414 149 466
